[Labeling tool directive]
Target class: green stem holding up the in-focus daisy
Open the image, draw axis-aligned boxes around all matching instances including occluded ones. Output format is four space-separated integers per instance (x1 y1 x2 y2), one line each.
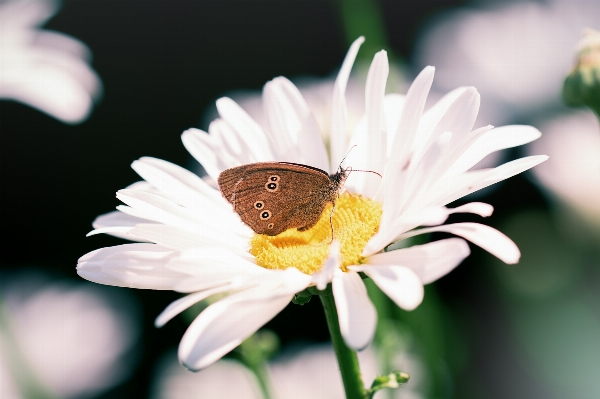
319 287 367 399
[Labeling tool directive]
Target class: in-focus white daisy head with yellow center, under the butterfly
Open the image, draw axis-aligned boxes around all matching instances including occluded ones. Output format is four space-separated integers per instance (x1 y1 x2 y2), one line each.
77 37 547 370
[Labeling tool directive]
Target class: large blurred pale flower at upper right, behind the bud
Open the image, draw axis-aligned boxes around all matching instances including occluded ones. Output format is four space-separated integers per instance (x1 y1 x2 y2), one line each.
415 1 600 124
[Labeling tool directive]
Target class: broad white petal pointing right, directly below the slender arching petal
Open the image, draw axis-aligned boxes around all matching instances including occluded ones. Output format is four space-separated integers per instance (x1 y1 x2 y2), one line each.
365 238 471 284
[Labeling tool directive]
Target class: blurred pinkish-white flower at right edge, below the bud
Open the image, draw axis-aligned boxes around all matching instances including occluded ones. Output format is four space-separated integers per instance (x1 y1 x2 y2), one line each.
528 111 600 226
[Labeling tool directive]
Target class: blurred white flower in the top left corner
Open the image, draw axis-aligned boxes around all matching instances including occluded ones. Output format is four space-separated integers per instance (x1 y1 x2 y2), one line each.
0 0 101 123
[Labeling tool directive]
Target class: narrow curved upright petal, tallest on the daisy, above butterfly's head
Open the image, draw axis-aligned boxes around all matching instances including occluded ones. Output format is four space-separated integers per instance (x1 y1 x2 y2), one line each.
330 36 365 171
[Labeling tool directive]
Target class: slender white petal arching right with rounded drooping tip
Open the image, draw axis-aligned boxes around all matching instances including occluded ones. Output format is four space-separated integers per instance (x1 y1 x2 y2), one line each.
398 223 521 264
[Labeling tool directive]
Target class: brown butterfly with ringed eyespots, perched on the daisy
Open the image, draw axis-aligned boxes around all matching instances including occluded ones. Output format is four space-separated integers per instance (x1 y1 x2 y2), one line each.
218 162 348 236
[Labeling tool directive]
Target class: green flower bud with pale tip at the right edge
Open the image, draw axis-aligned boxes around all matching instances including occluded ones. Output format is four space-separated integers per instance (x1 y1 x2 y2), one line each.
563 29 600 115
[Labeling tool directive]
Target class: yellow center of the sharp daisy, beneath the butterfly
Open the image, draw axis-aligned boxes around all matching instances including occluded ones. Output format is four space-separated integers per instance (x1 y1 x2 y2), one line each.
250 192 382 274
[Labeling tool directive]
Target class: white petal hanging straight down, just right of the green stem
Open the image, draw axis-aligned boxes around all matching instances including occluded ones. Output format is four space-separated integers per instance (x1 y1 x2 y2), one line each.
332 271 377 350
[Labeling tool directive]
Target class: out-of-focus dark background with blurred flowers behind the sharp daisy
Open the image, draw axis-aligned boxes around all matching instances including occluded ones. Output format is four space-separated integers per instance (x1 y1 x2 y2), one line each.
0 0 600 399
